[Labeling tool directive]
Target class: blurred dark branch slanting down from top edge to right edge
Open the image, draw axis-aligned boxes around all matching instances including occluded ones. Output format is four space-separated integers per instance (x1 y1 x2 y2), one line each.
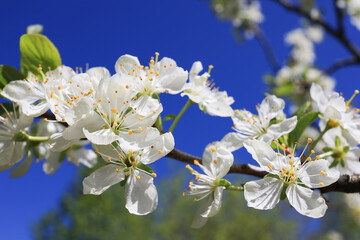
272 0 360 62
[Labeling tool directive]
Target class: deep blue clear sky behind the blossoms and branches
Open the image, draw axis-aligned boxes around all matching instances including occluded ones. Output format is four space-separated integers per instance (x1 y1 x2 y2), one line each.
0 0 360 239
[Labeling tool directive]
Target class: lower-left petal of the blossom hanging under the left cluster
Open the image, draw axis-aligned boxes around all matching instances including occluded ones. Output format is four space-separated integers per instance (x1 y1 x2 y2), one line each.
83 164 125 195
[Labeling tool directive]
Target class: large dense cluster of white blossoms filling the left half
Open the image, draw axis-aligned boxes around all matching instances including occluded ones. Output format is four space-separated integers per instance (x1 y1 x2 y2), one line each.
0 53 234 215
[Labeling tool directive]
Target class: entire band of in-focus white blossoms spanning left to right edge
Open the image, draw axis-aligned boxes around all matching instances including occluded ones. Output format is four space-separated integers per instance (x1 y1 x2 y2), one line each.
0 50 360 225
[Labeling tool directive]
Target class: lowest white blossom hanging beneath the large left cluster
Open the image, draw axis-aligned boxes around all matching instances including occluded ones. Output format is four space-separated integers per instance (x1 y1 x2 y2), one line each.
83 128 175 215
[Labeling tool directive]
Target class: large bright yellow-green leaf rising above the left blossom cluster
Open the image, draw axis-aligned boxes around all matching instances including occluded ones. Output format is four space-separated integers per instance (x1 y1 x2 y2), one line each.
20 34 61 76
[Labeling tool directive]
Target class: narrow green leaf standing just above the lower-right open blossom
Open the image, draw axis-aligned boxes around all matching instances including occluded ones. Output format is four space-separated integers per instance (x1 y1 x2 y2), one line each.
288 111 319 147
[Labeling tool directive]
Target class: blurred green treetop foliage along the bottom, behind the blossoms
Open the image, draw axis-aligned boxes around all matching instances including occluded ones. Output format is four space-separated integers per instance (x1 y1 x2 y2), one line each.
33 167 296 240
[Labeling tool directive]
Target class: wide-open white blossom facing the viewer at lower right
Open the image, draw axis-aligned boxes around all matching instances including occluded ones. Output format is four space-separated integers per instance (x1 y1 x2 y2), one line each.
244 140 340 218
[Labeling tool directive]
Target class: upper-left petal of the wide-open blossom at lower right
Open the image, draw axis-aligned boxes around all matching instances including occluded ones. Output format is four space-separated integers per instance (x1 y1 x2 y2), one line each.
244 140 281 171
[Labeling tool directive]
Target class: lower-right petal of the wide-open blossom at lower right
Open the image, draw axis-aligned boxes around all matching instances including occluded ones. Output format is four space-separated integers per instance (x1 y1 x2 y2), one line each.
286 184 327 218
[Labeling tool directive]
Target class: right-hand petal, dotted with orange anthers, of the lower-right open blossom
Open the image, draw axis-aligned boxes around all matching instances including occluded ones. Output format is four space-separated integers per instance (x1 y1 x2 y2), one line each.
299 159 340 188
